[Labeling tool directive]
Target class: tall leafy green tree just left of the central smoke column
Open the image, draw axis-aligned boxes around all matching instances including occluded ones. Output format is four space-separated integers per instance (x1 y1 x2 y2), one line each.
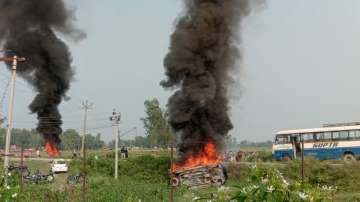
141 98 174 148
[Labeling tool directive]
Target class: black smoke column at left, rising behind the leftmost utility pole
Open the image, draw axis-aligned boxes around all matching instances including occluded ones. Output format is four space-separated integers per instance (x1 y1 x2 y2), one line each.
0 0 84 148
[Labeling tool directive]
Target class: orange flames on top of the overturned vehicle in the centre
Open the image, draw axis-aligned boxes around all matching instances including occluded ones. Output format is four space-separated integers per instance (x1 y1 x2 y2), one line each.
171 139 221 172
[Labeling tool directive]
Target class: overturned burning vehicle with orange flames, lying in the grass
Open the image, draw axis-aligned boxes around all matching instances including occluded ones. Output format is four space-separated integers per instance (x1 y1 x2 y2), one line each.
170 141 227 188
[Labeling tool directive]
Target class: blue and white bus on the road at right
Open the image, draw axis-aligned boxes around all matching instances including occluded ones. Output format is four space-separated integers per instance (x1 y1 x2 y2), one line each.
273 124 360 161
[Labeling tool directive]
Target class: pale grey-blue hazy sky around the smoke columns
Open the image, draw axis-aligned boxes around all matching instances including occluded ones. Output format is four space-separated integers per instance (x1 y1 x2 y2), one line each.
0 0 360 141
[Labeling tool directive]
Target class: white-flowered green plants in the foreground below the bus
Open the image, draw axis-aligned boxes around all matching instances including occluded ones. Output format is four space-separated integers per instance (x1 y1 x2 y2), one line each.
231 167 336 202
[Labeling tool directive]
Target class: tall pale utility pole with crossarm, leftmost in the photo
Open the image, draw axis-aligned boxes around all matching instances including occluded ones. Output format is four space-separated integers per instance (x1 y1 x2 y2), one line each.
0 55 26 181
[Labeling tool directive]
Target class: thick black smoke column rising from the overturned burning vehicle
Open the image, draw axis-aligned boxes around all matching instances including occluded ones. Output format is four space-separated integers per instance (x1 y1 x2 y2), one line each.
161 0 250 161
